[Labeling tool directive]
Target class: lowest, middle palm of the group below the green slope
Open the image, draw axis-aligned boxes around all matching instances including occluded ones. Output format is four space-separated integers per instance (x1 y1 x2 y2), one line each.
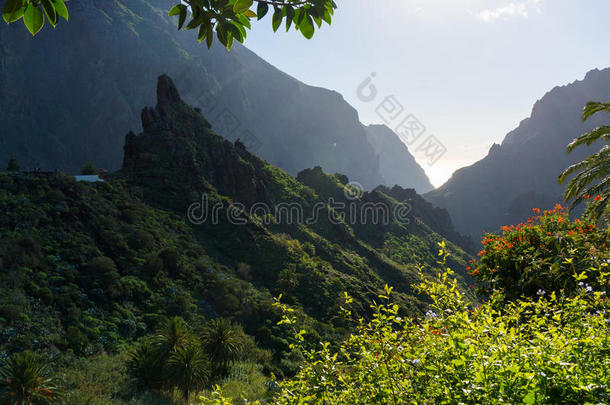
166 342 210 402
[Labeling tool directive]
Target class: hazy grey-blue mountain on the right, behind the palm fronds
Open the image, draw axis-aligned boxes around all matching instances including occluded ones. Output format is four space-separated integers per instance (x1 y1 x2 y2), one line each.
425 68 610 237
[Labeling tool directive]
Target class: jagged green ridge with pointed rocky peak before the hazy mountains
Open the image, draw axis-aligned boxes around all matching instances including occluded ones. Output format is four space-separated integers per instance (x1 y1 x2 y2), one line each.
0 76 469 368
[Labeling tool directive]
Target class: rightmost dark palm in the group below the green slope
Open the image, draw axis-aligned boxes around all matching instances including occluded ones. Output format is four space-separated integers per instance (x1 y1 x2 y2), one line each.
197 319 241 374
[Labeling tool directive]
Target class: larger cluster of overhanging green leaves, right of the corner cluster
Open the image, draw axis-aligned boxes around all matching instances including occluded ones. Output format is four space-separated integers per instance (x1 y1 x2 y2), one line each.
169 0 337 49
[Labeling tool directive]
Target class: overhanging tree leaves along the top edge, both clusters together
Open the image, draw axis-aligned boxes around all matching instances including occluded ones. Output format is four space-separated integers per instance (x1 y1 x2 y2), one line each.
2 0 337 49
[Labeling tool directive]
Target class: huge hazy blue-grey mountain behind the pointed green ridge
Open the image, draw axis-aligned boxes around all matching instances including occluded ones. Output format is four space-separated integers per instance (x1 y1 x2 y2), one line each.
0 0 427 191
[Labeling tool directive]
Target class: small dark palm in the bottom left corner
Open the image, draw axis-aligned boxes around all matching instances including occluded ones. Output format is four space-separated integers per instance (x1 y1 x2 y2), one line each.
0 352 60 405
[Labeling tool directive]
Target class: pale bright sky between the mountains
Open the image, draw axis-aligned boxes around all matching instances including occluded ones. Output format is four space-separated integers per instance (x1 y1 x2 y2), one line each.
240 0 610 186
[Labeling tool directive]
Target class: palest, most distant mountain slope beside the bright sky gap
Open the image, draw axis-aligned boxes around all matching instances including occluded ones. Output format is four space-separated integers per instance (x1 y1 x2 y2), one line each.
366 125 434 194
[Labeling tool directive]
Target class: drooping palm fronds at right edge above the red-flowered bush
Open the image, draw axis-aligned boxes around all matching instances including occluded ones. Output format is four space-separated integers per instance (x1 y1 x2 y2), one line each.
559 102 610 218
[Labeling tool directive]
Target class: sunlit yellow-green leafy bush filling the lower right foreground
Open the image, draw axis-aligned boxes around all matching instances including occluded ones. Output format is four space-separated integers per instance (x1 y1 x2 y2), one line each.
201 241 610 404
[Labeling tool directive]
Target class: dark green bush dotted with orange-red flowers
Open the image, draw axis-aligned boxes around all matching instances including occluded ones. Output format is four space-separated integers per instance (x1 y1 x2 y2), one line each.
467 201 610 300
